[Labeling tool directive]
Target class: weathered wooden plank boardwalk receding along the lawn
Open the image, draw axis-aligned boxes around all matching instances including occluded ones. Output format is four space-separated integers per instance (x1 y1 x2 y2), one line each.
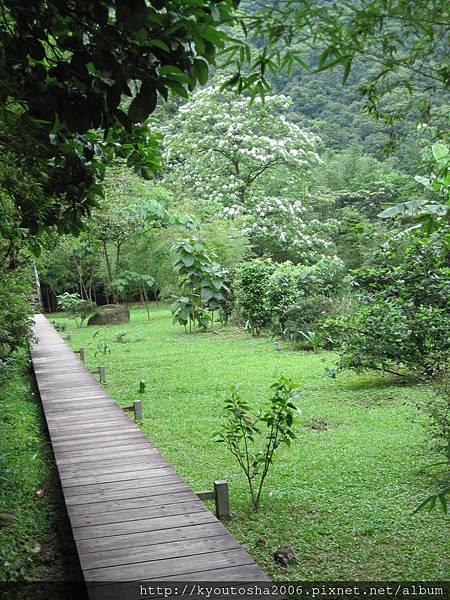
31 314 267 600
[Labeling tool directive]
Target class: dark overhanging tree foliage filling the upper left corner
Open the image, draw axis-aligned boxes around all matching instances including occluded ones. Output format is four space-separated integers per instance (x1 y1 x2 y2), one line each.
0 0 237 252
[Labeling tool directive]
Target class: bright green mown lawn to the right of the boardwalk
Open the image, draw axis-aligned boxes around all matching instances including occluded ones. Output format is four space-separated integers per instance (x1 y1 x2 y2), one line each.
52 307 450 580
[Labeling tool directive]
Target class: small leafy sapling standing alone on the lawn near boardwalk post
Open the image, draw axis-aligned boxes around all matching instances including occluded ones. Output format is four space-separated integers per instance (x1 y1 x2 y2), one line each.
216 377 299 510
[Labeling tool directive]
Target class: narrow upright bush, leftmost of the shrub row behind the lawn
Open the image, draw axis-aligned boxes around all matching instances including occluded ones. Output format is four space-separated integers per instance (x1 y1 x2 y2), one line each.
236 259 275 334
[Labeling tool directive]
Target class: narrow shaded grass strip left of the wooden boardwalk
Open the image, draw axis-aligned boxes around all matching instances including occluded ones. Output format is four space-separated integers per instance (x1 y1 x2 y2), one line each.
0 354 80 598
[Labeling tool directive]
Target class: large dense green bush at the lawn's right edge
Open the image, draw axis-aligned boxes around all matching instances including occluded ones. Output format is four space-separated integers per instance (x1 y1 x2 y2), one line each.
325 236 450 377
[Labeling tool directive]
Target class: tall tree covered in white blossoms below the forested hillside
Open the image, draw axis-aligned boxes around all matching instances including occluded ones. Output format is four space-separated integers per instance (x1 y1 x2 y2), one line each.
161 87 336 261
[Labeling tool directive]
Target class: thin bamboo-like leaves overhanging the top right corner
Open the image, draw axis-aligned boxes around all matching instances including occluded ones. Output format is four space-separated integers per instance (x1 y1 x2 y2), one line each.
227 0 450 139
